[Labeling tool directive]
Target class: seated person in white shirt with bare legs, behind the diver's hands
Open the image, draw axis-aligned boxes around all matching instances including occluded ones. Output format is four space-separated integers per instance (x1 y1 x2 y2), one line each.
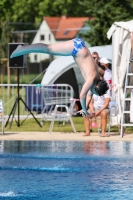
83 90 111 137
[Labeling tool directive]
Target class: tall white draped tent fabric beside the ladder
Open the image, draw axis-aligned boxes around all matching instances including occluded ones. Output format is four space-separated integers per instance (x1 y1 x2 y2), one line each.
107 20 133 122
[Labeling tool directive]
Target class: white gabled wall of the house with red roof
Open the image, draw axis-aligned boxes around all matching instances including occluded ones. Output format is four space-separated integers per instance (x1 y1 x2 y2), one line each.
29 20 56 63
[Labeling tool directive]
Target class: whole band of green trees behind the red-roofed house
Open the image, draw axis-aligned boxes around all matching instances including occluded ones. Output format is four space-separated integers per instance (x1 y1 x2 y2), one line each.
0 0 133 45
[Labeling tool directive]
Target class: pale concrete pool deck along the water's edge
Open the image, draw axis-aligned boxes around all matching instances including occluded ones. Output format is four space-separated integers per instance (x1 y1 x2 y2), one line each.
0 132 133 141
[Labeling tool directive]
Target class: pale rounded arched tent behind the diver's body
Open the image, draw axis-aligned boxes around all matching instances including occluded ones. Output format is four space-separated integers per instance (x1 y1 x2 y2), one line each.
41 45 112 84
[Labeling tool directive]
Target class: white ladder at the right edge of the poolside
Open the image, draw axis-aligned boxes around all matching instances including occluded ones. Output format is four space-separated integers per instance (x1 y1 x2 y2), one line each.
121 56 133 137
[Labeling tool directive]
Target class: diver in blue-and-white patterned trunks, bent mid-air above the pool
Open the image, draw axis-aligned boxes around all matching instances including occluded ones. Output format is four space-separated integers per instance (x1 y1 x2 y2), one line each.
10 38 108 116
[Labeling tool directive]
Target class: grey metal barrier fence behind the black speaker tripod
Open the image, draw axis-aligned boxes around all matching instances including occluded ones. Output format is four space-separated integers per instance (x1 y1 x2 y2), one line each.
0 84 74 117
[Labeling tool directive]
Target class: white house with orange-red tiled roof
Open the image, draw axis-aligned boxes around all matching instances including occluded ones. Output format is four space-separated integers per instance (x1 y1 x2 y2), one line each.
29 16 94 62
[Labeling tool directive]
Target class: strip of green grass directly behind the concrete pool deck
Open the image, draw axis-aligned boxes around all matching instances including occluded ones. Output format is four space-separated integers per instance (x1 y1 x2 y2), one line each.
5 117 133 133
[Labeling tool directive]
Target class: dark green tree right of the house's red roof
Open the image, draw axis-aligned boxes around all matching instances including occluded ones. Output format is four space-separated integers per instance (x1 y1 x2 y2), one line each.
82 0 133 46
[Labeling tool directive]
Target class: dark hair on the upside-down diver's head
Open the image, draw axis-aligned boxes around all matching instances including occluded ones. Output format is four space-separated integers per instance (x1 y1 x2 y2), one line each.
95 80 109 96
